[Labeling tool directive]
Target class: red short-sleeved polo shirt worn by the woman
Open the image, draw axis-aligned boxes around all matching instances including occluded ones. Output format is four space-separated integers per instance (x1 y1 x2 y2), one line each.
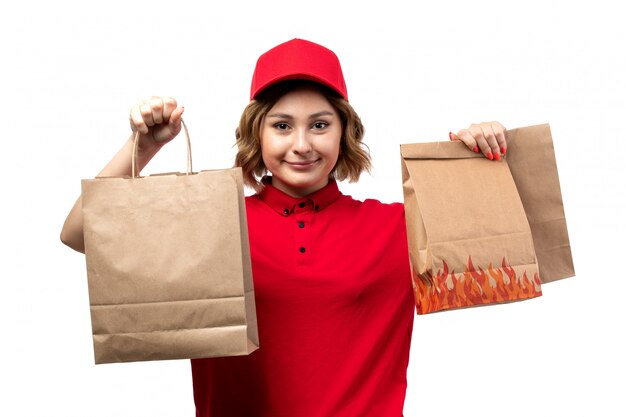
191 181 415 417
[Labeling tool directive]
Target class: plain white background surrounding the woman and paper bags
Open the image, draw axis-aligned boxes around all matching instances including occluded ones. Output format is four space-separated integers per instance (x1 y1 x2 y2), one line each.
0 0 626 417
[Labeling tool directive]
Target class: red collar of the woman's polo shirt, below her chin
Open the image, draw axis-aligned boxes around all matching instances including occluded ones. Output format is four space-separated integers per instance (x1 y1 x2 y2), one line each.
258 176 341 217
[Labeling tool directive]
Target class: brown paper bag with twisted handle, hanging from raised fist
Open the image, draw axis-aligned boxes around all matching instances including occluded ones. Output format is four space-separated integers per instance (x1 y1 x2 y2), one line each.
82 122 259 363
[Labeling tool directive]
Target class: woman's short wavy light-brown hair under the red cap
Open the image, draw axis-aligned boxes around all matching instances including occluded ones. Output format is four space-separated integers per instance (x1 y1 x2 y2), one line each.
235 80 372 191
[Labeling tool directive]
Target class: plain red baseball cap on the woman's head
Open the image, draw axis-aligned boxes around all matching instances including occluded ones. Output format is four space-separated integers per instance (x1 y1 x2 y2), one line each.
250 39 348 100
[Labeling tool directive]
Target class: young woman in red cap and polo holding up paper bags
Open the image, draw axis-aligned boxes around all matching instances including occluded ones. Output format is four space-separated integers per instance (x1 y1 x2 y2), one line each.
61 39 506 417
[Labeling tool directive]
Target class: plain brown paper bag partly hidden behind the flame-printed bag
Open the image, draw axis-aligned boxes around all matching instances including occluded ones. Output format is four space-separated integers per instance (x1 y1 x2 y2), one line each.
506 124 575 283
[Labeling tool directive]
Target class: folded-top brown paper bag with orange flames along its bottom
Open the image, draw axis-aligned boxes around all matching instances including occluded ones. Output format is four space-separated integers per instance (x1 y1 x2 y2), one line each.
401 136 541 314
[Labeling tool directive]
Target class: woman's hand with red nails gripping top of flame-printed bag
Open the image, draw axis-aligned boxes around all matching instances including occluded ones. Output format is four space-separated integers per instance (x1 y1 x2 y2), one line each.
450 122 506 161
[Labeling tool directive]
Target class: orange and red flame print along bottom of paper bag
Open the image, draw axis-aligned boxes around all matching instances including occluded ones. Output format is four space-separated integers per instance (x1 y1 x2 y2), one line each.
412 256 541 314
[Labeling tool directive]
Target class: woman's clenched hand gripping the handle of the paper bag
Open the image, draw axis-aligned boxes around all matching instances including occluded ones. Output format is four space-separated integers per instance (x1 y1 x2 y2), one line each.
130 96 185 151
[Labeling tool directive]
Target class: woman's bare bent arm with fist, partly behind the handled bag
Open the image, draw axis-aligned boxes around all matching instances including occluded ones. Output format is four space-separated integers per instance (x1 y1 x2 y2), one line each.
61 97 184 253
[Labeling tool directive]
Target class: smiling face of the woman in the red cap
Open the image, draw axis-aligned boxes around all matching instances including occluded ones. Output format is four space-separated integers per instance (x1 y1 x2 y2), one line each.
261 87 342 197
